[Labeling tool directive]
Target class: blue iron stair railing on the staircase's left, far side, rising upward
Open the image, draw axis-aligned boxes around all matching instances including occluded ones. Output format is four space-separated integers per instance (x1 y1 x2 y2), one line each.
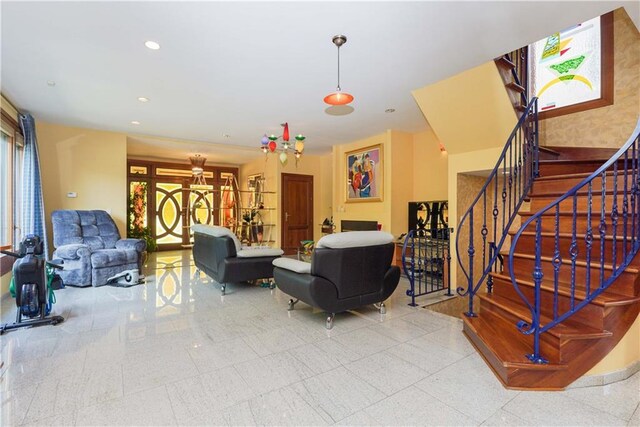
456 97 539 317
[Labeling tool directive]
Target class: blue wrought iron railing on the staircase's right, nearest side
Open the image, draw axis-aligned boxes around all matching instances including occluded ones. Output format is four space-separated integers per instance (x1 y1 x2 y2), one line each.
509 120 640 363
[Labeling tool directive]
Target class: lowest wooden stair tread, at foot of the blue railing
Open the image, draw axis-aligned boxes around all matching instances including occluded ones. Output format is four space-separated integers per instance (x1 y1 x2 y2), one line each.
462 315 567 371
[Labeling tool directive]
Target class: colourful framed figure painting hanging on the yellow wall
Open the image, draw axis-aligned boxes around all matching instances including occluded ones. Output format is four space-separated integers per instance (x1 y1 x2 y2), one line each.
345 144 384 203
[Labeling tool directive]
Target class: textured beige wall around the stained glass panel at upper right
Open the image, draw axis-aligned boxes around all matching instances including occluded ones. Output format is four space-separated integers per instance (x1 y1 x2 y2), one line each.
540 8 640 148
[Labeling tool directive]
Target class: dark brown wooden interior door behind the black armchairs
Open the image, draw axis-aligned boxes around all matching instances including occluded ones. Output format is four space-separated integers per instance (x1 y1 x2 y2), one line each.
280 173 313 254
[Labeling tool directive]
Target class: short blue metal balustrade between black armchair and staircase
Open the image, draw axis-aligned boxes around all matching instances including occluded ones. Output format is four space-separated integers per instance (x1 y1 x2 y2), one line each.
402 228 453 307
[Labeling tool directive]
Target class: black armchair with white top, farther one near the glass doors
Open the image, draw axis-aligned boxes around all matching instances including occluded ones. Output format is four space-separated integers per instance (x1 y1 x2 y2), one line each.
191 224 283 295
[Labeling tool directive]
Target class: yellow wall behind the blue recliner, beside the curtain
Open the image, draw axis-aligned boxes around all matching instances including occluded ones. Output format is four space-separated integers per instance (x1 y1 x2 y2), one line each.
36 122 127 250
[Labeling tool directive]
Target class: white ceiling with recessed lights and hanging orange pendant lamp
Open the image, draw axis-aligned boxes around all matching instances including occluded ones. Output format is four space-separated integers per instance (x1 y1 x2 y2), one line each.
0 1 640 163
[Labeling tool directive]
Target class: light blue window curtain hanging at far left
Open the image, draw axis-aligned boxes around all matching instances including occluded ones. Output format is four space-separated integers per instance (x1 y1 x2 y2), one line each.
19 113 49 259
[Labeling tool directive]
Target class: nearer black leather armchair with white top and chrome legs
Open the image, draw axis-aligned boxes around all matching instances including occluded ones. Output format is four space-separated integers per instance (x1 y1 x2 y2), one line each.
273 231 400 329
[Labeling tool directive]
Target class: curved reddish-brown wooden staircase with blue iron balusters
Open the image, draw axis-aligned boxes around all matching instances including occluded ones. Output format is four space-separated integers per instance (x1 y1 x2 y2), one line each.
464 150 640 390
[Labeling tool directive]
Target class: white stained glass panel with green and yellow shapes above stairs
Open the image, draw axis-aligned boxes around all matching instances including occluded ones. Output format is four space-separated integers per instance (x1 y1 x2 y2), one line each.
529 17 602 112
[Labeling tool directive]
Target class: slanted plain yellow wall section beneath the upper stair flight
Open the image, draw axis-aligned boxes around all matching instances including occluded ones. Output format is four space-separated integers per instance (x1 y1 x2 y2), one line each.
412 61 517 155
